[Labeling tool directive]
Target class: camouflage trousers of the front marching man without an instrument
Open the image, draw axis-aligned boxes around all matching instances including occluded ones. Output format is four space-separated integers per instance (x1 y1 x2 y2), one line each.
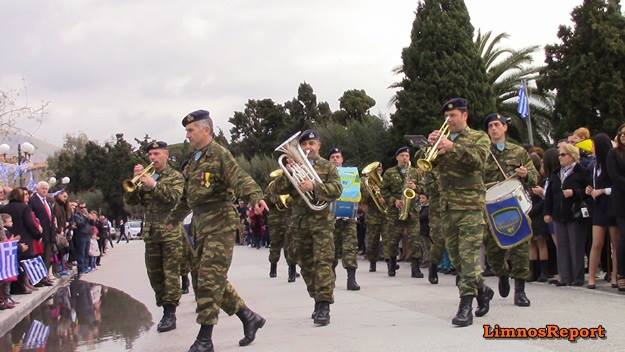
191 227 245 325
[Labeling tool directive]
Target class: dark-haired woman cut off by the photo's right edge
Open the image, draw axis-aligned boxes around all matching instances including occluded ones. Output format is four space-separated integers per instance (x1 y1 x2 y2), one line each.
606 124 625 291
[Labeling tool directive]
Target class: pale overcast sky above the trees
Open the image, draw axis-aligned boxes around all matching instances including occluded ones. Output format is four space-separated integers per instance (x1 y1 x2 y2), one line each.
0 0 582 146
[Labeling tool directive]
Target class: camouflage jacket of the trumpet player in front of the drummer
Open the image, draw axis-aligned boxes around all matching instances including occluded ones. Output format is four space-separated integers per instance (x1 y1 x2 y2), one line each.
433 127 490 211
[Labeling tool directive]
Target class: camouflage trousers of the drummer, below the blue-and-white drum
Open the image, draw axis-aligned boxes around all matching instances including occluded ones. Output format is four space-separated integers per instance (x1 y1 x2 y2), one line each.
484 228 530 280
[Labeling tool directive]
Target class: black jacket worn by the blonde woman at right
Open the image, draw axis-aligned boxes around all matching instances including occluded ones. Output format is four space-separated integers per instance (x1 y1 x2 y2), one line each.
544 163 591 222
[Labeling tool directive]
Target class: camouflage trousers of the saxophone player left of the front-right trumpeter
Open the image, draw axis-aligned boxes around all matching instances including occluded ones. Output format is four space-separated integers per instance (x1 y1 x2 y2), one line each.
382 213 423 261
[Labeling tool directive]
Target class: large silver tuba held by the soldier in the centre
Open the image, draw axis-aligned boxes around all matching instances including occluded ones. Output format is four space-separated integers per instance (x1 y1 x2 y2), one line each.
275 132 328 211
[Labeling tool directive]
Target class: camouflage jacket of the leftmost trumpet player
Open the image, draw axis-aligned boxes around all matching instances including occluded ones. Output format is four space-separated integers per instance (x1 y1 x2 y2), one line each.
124 166 184 242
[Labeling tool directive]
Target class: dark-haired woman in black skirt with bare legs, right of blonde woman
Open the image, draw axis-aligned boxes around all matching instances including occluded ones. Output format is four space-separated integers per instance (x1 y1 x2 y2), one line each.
586 133 619 289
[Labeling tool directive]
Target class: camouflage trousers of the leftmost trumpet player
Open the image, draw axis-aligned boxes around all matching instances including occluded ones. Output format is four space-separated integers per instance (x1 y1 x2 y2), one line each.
145 240 182 307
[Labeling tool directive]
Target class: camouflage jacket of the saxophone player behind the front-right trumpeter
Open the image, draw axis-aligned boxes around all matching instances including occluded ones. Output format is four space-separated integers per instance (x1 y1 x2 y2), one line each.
382 166 423 220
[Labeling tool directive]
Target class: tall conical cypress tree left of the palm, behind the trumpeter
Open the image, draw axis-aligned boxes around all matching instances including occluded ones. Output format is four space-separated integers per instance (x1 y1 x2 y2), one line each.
391 0 495 138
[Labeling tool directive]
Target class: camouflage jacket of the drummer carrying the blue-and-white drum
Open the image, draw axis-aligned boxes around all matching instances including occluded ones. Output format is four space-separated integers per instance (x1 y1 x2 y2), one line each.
484 142 538 187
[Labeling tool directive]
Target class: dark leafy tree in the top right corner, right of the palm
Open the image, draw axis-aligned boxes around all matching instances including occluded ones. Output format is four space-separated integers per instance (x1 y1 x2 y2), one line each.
539 0 625 136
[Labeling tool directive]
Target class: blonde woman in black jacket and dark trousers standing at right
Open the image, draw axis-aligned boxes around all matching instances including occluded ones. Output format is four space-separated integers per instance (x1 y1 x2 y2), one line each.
544 143 590 286
